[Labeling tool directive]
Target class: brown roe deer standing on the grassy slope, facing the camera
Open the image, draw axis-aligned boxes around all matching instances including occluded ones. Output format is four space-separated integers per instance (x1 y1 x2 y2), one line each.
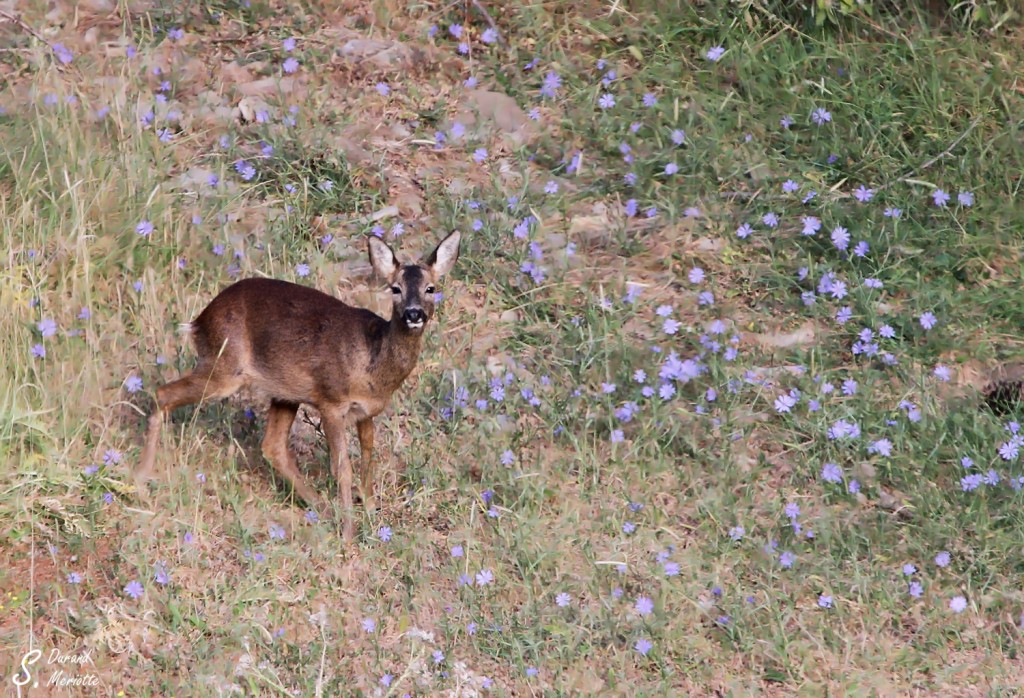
136 231 460 542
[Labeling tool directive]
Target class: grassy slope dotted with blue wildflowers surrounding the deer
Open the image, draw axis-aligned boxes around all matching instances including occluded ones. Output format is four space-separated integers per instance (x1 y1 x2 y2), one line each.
6 3 1024 696
